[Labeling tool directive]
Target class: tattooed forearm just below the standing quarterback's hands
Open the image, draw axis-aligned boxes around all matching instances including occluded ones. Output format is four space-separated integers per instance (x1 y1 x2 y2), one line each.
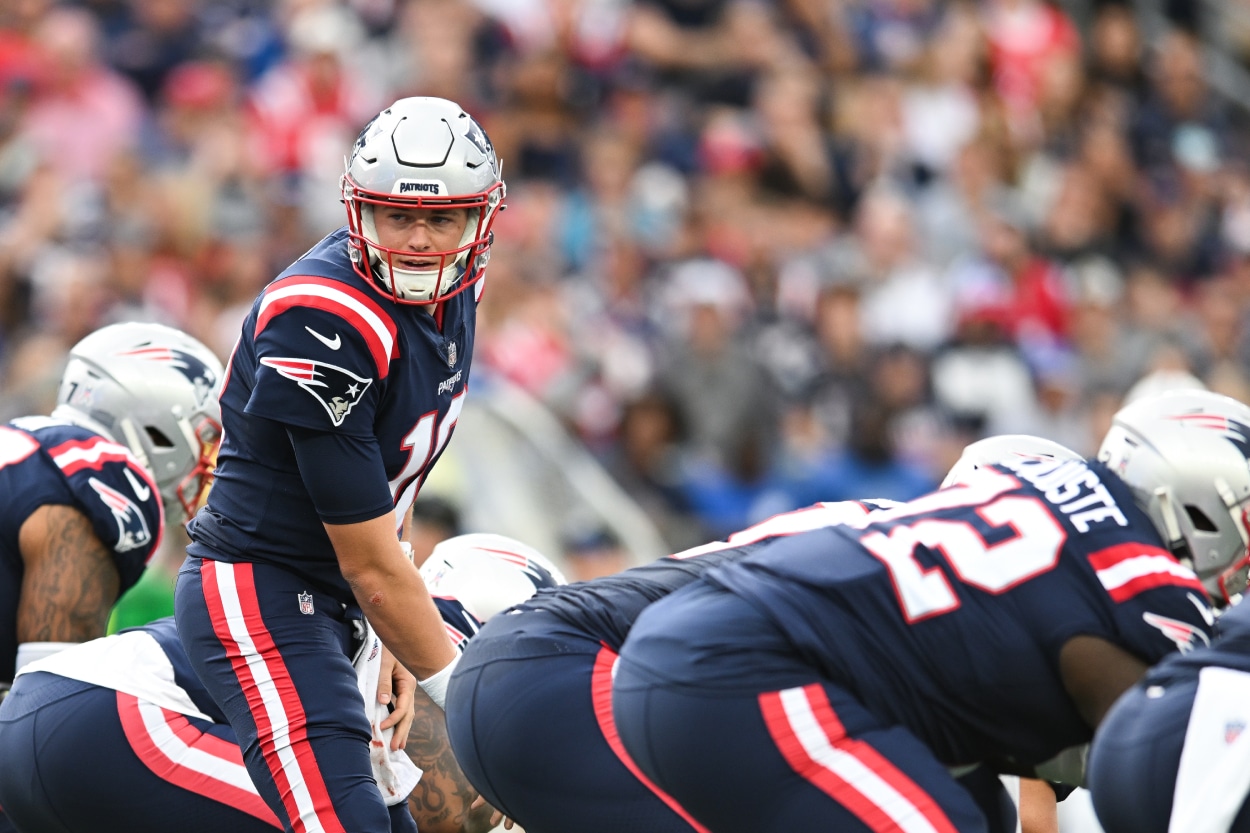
404 690 493 833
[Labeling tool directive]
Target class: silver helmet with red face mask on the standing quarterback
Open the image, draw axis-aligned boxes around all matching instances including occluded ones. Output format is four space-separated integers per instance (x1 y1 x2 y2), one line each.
343 98 506 304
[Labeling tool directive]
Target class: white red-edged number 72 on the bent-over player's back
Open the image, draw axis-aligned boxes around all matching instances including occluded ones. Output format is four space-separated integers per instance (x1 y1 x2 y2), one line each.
860 477 1068 622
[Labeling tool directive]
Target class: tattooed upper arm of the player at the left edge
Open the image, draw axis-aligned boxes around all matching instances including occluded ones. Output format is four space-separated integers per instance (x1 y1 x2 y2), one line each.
18 505 121 643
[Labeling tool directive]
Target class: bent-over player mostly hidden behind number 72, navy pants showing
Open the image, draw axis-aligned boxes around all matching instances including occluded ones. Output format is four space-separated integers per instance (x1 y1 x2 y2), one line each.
448 437 1079 833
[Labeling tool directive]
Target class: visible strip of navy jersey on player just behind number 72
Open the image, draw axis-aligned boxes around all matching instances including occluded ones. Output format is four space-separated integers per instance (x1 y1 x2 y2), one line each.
514 500 894 652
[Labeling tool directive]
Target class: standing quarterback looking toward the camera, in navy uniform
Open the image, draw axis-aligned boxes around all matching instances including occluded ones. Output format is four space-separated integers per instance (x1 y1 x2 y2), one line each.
174 98 504 830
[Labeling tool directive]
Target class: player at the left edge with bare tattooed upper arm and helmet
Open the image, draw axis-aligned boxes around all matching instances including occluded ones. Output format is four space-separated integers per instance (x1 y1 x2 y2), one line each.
0 317 223 684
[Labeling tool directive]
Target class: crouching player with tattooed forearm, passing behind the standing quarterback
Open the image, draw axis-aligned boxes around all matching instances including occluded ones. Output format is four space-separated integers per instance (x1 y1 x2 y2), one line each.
0 534 564 833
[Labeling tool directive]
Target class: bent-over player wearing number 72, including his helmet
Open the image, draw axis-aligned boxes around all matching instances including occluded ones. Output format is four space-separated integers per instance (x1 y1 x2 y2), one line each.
613 399 1250 833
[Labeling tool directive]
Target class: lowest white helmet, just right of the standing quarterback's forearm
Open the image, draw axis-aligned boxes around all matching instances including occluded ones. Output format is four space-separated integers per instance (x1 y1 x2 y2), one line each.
421 533 569 622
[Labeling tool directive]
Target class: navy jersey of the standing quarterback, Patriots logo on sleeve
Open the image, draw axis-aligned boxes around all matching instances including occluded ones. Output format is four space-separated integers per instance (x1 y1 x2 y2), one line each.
188 229 483 603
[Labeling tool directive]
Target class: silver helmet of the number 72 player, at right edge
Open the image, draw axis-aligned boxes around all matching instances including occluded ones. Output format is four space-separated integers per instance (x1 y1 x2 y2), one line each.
1098 390 1250 604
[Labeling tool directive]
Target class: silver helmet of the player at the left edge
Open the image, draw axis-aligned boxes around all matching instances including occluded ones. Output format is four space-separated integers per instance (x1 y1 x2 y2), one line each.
53 323 225 518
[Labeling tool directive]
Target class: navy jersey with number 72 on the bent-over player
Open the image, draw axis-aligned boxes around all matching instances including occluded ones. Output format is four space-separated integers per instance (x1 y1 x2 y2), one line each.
691 458 1213 764
